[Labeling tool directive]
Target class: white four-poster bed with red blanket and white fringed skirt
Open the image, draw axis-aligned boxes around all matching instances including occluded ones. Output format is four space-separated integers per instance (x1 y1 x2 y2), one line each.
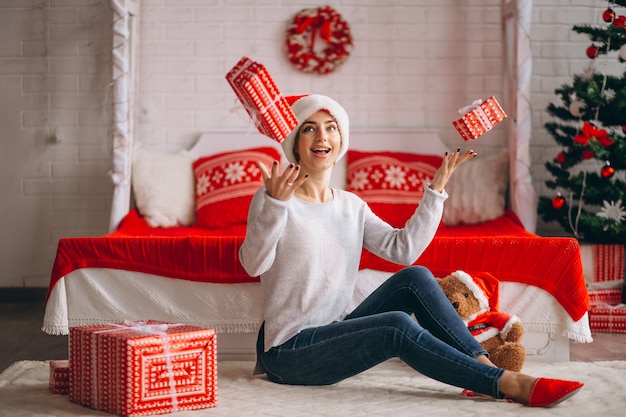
43 0 592 361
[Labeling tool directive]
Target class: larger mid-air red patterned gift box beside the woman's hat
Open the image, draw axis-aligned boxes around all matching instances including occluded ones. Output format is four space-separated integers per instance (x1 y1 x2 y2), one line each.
226 56 298 142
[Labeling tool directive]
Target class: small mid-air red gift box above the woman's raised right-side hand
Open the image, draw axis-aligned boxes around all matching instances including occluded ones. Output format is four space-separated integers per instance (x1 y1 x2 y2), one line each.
452 96 506 141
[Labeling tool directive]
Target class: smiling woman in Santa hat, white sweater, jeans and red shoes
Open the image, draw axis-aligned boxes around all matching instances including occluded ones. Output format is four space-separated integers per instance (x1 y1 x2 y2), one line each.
240 95 583 407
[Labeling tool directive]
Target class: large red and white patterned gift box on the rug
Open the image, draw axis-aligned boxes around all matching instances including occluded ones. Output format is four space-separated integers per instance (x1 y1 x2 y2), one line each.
69 321 217 416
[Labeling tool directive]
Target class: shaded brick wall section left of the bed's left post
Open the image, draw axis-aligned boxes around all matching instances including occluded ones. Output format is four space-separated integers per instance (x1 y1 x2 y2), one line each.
0 0 112 287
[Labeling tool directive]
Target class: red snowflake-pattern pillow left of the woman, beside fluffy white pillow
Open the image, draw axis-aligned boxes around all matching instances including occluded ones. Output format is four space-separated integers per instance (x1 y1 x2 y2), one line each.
193 147 280 229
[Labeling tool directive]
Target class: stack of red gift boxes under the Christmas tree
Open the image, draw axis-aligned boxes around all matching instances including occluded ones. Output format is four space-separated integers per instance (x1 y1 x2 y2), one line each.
586 244 626 333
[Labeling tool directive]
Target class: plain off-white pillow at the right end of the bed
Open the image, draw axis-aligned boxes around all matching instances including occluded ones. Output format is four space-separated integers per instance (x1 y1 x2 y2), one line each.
443 151 509 226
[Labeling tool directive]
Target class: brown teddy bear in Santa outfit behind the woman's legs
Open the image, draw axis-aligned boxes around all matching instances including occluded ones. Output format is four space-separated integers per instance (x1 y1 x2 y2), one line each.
437 271 526 371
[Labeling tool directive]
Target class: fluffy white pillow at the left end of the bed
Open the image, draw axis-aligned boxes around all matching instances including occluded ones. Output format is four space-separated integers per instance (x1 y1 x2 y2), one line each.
132 145 196 227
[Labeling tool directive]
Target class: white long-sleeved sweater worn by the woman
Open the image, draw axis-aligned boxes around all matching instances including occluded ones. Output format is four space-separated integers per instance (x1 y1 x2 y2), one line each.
239 187 447 351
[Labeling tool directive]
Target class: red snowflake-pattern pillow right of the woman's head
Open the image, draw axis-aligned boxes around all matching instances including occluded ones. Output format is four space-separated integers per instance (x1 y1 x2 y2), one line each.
346 150 443 228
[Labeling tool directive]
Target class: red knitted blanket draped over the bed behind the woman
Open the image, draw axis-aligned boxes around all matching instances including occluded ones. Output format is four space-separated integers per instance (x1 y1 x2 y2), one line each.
48 210 589 320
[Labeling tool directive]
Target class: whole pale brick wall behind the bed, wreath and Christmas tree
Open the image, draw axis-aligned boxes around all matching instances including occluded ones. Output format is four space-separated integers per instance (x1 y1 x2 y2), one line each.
0 0 603 287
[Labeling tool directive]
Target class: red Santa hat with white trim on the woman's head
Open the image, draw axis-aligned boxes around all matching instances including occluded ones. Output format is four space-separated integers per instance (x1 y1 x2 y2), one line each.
281 94 350 163
